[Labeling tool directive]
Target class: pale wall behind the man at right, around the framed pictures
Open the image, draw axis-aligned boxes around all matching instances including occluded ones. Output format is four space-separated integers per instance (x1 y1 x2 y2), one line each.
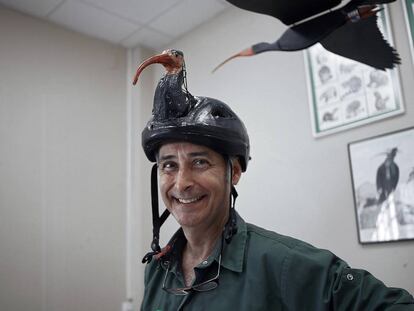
136 2 414 293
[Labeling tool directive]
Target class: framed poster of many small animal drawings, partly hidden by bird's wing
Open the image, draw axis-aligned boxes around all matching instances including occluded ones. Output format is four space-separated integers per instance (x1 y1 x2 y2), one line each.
305 5 404 137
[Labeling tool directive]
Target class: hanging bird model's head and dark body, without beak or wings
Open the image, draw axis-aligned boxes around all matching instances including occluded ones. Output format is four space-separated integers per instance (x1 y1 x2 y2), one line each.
252 10 346 54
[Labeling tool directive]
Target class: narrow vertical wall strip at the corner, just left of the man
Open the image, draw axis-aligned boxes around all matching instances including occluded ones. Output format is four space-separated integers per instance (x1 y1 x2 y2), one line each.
127 48 154 310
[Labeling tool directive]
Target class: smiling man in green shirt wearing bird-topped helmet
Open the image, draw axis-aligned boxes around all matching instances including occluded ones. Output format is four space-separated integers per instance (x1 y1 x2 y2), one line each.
137 50 414 311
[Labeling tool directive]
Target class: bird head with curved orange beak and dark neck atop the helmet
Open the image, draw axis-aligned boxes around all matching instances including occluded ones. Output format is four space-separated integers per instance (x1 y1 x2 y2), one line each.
133 49 195 121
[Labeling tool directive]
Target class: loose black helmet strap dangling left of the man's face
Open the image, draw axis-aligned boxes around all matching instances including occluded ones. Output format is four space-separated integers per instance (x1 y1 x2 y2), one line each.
142 164 170 263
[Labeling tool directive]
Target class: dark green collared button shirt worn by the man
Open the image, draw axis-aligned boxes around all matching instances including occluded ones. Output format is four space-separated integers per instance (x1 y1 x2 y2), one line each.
141 216 414 311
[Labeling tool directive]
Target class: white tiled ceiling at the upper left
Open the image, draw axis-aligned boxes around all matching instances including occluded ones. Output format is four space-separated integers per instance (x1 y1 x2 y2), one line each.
0 0 231 50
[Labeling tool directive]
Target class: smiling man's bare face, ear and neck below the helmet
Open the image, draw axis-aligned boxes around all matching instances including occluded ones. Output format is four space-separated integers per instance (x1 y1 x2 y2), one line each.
158 142 241 286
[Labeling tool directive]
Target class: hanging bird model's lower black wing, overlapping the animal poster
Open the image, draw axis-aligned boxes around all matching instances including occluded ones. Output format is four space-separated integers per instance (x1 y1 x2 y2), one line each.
321 15 401 70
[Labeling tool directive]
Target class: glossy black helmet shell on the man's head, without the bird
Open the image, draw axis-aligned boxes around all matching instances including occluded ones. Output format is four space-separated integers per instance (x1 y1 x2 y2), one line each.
142 97 250 172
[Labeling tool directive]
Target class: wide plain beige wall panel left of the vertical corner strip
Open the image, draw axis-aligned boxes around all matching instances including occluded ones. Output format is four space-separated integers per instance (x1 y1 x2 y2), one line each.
0 7 126 311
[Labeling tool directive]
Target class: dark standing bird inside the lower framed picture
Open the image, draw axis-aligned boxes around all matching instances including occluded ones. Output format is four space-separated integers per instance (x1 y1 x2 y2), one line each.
377 147 400 204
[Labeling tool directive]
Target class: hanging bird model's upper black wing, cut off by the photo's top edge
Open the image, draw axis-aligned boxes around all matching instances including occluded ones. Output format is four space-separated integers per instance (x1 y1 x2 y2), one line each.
227 0 342 25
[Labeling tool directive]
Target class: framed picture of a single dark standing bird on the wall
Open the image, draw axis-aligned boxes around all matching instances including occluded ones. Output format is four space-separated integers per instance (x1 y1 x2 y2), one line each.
348 127 414 243
